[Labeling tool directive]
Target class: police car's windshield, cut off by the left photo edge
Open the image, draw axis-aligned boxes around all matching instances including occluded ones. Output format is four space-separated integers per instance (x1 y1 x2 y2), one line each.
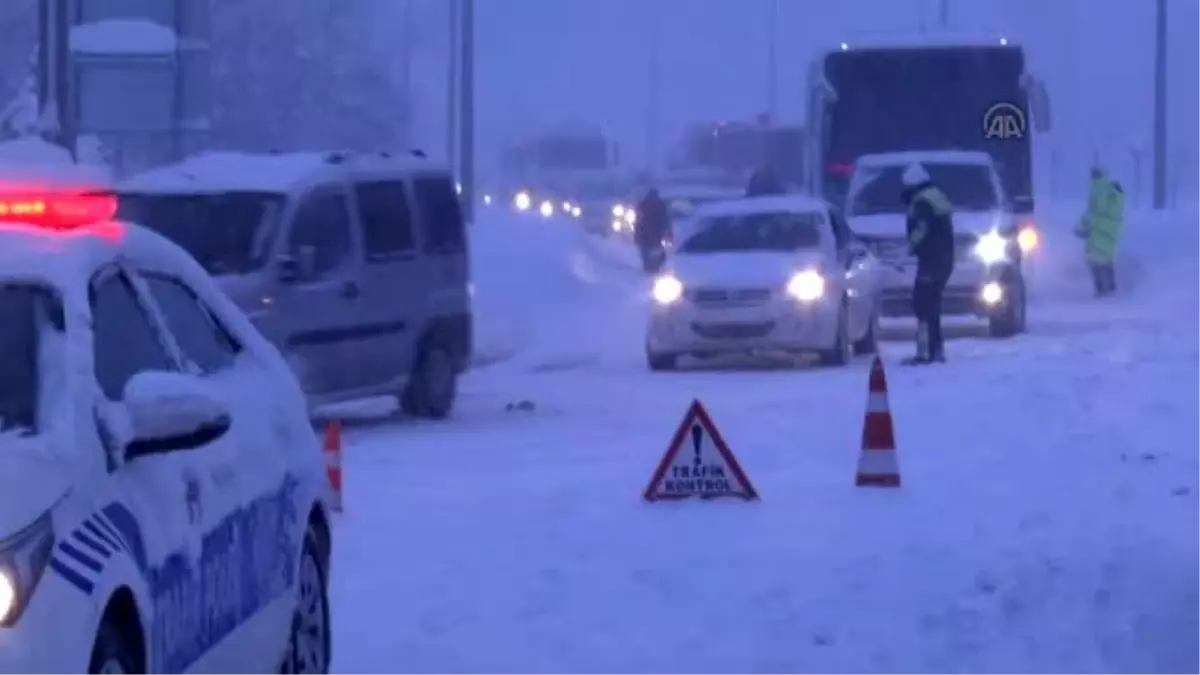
0 283 62 436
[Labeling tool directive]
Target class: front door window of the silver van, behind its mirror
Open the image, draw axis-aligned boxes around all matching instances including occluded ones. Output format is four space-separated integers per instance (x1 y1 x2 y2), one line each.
288 190 354 279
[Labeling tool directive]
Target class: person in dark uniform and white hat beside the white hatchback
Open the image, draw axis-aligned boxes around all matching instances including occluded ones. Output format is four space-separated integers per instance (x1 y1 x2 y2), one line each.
901 163 954 365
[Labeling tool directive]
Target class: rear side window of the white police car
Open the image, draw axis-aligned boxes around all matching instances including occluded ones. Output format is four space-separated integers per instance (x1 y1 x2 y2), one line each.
143 273 241 375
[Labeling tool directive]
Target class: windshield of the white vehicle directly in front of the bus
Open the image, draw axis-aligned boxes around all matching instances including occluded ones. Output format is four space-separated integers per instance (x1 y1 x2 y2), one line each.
850 162 1001 216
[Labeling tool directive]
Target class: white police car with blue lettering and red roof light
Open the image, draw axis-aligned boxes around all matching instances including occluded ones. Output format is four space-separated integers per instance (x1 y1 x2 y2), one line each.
0 187 331 675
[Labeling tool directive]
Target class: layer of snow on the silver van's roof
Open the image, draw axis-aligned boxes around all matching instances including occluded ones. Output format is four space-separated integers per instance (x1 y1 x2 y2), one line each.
118 153 442 193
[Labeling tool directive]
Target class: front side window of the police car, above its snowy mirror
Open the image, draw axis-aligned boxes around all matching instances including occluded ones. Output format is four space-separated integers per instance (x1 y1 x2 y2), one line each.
91 274 176 401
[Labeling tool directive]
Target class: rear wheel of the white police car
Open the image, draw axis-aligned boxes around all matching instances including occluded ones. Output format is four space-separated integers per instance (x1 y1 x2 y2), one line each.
278 530 332 675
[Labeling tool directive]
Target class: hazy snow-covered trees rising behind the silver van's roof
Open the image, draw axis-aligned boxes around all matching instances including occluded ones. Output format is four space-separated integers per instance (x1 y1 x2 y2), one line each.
211 0 422 150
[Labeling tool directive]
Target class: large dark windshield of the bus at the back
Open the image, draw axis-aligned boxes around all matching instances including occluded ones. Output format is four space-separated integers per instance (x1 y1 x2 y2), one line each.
823 46 1032 207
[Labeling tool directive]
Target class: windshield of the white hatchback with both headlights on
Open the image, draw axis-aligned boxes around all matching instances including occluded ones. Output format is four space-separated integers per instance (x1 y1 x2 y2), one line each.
678 213 823 255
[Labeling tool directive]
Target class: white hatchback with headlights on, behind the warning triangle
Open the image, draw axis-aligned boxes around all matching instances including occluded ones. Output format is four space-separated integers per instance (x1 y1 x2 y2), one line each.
646 195 880 370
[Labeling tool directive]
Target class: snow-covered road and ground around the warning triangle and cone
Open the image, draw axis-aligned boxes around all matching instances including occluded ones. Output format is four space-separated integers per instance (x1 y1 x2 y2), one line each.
332 208 1200 675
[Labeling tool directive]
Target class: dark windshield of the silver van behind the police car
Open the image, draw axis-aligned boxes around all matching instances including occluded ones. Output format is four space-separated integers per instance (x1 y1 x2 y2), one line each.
118 192 283 275
